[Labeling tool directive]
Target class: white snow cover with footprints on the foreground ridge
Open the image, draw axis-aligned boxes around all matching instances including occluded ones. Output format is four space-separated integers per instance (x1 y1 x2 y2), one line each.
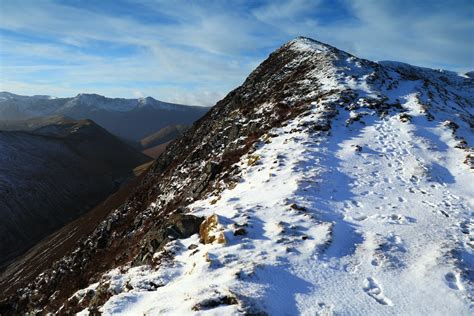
79 40 474 315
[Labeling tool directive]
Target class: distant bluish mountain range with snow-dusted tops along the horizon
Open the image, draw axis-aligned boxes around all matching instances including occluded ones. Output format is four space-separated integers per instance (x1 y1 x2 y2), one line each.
0 92 209 141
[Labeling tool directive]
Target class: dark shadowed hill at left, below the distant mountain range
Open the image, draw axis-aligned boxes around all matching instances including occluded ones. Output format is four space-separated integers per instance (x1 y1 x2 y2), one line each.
0 119 148 266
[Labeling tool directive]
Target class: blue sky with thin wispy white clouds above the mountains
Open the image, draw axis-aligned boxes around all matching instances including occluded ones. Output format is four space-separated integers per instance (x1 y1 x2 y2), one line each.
0 0 474 105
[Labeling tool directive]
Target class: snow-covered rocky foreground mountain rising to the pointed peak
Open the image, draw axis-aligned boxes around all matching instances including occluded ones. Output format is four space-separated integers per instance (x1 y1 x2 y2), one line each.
0 38 474 315
